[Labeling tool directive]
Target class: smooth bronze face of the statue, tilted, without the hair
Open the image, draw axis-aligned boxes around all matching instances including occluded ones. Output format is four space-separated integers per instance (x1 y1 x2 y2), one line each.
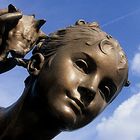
37 41 126 130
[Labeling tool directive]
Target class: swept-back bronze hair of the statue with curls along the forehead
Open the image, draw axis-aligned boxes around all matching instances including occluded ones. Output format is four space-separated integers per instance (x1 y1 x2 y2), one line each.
29 20 128 86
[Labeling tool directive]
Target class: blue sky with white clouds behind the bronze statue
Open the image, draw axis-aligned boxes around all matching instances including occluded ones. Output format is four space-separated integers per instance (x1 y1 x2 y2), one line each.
0 0 140 140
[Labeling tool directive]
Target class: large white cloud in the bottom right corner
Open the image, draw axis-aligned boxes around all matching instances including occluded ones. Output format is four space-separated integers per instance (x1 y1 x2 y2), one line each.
96 93 140 140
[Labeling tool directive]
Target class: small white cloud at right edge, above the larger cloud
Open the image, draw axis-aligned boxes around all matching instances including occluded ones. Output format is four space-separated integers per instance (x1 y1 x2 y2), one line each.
131 53 140 74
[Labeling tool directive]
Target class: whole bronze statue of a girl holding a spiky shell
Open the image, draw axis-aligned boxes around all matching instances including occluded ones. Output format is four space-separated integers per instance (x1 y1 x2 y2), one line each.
0 5 129 140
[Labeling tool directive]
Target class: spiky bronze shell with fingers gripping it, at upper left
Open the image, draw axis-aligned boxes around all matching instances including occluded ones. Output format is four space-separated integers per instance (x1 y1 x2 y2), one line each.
0 4 47 73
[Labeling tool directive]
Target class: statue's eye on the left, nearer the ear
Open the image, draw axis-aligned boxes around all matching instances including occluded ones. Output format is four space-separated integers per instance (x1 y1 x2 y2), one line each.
75 59 89 74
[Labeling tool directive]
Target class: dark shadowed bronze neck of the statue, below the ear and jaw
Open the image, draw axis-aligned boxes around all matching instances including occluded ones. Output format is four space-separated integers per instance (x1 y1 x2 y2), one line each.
0 78 60 140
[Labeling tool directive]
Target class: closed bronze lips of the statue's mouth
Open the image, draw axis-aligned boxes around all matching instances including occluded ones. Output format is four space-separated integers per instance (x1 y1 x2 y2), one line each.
66 91 85 115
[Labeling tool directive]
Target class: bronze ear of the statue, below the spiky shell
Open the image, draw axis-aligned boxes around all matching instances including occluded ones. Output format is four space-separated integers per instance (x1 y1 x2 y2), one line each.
27 53 45 76
